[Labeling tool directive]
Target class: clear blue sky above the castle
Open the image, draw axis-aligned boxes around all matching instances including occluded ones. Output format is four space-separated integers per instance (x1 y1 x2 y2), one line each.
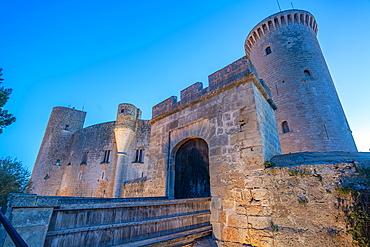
0 0 370 173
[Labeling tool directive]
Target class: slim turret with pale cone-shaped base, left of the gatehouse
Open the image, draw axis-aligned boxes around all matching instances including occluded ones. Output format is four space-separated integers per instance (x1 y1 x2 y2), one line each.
113 104 141 197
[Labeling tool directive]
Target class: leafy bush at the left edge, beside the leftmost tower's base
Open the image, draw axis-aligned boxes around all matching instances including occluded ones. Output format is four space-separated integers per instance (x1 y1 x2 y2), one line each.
0 157 31 206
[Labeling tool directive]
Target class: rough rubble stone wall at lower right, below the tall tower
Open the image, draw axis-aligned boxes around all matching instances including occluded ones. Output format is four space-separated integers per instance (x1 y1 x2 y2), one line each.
211 154 370 247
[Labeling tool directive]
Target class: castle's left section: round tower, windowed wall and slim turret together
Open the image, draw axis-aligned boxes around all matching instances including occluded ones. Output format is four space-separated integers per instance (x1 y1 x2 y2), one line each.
32 104 150 197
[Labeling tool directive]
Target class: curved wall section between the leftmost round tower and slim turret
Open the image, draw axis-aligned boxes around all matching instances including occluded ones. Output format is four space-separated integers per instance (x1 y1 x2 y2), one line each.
60 122 116 197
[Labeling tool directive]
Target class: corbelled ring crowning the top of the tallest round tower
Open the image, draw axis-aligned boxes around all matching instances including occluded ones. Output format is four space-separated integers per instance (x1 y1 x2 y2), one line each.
244 9 318 57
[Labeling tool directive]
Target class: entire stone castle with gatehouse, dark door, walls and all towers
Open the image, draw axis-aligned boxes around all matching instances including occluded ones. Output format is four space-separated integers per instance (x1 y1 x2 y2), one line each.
24 10 366 246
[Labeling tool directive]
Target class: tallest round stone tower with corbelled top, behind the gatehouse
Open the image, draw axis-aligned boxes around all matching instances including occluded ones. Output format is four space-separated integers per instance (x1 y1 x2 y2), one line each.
245 10 357 153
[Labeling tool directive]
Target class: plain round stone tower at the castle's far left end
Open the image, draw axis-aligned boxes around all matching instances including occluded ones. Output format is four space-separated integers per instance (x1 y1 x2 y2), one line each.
31 107 86 196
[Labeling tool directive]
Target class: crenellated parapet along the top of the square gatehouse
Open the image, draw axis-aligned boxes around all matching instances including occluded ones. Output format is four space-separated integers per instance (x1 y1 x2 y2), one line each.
152 57 275 119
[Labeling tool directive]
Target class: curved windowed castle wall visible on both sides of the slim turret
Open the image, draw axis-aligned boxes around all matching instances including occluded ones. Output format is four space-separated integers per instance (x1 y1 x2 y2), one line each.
58 120 150 197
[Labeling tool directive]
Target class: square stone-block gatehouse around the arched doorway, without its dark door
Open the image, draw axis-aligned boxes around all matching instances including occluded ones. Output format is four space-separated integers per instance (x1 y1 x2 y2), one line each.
143 58 281 244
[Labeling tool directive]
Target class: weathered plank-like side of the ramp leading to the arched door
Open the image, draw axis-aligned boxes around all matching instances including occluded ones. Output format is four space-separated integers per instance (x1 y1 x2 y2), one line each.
44 198 212 247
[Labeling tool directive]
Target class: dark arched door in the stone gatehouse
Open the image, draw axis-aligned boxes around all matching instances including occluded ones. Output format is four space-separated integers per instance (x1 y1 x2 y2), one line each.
175 138 211 198
